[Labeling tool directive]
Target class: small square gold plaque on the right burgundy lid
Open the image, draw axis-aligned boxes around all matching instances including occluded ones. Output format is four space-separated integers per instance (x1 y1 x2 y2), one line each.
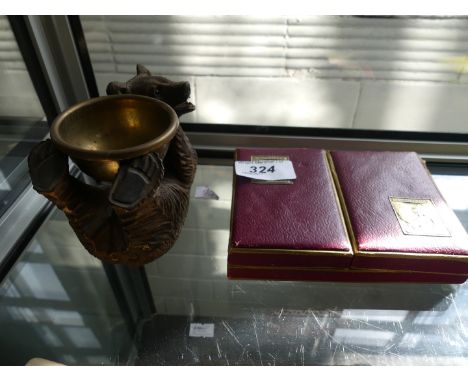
390 197 451 237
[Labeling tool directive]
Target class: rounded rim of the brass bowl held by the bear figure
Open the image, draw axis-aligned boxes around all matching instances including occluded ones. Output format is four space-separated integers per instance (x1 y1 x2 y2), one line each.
50 94 179 160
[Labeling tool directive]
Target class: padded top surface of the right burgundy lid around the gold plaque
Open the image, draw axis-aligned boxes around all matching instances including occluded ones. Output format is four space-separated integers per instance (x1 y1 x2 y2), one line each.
331 151 468 258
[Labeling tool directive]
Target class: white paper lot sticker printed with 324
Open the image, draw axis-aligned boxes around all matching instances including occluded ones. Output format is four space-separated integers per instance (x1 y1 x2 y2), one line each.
234 160 296 180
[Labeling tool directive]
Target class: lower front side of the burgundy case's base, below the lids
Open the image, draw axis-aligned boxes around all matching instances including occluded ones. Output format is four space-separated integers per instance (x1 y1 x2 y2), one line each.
228 266 466 284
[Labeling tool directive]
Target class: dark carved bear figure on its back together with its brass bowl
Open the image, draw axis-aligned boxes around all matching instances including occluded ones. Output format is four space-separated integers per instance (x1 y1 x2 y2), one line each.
28 64 197 266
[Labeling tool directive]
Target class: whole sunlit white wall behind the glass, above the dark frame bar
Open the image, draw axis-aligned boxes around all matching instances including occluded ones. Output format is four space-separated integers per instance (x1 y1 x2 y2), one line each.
82 16 468 132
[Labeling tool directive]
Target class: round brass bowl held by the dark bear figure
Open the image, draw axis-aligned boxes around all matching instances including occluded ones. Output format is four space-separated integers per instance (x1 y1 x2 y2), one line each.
50 94 179 182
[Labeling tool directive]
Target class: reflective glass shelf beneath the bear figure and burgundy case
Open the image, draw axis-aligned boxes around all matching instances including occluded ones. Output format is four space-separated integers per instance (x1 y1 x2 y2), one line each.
0 165 468 365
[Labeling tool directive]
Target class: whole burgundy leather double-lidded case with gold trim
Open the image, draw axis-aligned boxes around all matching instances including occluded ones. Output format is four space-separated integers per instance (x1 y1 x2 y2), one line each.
228 149 468 283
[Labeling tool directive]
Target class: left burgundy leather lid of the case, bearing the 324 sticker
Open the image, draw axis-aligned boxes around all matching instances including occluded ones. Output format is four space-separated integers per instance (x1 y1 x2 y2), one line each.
230 148 351 252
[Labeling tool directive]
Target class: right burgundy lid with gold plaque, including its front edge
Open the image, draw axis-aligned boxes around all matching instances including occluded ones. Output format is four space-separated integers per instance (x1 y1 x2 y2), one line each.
330 151 468 278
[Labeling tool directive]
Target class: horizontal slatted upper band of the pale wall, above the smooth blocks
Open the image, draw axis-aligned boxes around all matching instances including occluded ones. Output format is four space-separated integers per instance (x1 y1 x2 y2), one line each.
81 16 468 83
